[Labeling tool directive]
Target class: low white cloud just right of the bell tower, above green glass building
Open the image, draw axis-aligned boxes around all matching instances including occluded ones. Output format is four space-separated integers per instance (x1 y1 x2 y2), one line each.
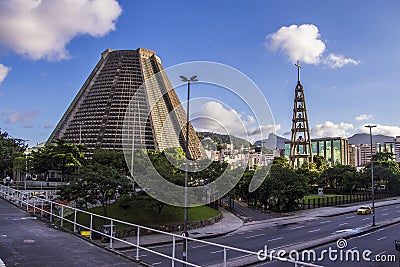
311 121 354 138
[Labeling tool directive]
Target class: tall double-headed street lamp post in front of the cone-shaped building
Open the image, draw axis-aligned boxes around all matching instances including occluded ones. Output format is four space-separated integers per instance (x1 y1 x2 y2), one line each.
179 76 198 266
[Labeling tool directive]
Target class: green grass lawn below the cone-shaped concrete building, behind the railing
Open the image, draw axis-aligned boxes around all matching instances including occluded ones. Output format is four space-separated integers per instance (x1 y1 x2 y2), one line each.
67 199 220 229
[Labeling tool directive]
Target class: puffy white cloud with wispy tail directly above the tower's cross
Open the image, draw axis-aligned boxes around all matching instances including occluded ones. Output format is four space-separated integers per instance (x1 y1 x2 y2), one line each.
266 24 359 68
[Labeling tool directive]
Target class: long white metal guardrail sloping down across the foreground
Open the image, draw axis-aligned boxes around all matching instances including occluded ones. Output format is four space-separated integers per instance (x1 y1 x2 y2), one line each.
0 185 319 267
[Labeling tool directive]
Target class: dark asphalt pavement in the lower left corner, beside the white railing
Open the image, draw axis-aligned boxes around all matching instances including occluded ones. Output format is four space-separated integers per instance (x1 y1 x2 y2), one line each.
0 199 139 267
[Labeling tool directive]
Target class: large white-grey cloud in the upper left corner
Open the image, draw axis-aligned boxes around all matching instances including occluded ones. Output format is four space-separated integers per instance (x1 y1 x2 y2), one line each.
0 0 122 60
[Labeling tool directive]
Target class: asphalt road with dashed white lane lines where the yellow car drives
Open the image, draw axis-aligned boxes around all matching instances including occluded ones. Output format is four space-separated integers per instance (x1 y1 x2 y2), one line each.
129 205 400 266
